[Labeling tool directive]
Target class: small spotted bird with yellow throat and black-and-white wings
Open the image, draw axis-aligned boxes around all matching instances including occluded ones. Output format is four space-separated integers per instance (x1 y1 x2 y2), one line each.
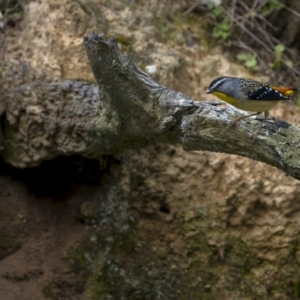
206 76 299 140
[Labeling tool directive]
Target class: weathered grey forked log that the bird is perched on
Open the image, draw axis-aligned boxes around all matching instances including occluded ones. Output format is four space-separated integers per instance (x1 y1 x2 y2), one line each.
2 34 300 179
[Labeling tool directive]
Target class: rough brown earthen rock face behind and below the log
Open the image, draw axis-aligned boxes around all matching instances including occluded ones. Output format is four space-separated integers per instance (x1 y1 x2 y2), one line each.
0 0 300 300
